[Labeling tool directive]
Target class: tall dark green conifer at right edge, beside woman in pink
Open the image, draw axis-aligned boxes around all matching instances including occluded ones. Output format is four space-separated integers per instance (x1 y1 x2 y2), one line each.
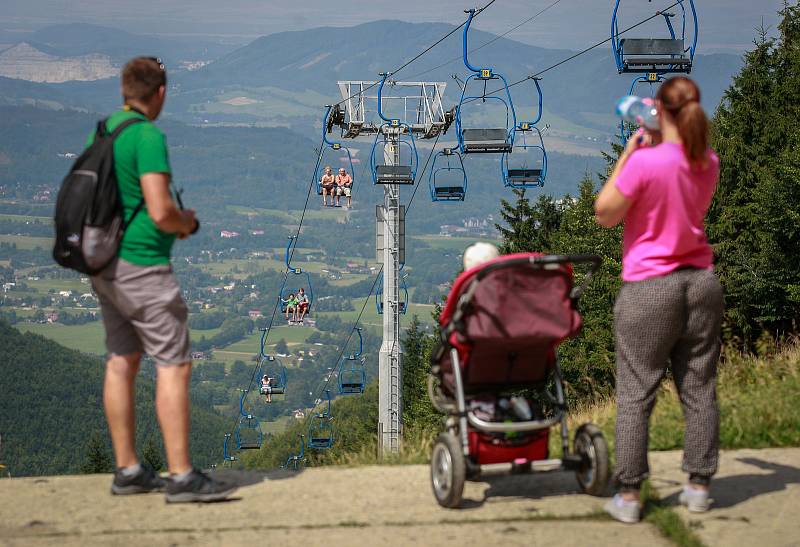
706 4 800 350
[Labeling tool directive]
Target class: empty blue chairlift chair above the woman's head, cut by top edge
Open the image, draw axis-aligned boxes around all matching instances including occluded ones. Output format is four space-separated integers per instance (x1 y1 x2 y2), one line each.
611 0 698 74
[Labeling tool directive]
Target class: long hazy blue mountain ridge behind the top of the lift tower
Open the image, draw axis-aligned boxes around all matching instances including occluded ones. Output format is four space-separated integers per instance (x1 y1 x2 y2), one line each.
178 20 741 128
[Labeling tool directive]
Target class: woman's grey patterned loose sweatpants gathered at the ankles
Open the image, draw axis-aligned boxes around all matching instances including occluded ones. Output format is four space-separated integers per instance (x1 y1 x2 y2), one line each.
614 269 723 488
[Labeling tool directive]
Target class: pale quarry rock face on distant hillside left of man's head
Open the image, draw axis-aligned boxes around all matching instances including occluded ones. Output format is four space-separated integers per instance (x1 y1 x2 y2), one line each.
0 42 119 83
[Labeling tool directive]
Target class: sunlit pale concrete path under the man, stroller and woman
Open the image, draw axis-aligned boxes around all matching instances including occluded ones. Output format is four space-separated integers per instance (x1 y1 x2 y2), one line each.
0 449 800 547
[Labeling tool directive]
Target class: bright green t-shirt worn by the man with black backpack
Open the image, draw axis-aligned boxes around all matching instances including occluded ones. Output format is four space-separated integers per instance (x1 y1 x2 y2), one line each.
87 110 175 266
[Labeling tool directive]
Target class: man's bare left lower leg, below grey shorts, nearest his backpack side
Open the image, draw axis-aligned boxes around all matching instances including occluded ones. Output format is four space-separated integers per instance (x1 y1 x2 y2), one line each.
103 353 141 467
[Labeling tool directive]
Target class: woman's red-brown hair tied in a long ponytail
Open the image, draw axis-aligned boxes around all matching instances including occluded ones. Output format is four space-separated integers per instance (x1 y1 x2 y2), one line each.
656 76 708 168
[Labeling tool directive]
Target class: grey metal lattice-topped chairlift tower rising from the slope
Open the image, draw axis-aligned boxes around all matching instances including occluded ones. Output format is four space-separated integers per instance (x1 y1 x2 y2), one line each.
332 76 452 455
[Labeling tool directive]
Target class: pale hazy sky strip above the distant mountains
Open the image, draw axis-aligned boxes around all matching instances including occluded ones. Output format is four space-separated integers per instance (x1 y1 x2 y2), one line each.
0 0 782 53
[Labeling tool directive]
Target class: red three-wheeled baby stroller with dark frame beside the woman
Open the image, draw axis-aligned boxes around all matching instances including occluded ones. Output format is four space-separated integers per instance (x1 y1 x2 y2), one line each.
428 253 609 507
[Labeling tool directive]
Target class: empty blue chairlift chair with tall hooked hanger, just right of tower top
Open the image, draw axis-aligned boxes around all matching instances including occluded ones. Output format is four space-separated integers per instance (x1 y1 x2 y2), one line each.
455 9 517 154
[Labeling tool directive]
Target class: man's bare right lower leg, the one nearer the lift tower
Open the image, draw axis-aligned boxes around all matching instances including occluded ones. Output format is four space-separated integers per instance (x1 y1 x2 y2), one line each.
156 363 192 474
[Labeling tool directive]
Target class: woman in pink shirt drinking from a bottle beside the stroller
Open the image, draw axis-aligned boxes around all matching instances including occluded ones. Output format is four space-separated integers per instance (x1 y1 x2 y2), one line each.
595 76 723 522
